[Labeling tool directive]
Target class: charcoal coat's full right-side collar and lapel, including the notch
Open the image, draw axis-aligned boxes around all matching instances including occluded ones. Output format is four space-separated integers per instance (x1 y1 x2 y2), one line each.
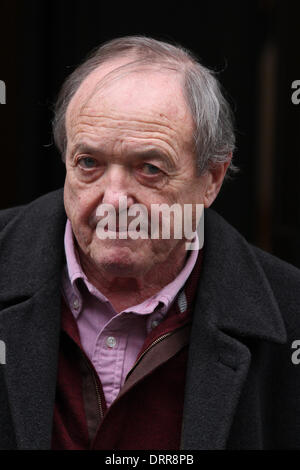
181 210 286 450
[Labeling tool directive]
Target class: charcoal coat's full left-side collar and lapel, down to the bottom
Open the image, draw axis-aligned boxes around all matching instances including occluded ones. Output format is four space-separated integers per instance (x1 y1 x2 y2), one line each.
0 191 66 449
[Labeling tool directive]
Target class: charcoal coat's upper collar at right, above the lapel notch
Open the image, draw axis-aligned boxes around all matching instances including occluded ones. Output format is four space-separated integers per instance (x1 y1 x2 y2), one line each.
198 210 286 343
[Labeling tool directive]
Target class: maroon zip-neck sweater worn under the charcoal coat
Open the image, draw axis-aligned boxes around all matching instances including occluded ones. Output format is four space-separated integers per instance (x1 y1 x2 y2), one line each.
52 251 202 450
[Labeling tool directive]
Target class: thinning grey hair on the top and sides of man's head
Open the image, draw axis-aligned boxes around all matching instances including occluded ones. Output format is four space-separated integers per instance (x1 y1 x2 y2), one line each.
53 36 238 176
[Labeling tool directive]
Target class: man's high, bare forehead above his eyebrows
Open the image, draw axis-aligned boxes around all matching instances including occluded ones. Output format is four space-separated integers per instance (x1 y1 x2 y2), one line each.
66 57 193 140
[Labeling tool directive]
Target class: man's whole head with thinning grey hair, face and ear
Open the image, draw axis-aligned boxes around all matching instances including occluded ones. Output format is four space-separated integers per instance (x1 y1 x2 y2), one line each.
54 37 234 277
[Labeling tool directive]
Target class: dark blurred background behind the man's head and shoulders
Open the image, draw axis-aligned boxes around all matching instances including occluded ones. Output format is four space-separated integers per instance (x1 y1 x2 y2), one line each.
0 0 300 267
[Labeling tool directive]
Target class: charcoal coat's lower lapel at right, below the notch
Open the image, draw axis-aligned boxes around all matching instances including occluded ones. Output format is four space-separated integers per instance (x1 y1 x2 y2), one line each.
181 310 250 450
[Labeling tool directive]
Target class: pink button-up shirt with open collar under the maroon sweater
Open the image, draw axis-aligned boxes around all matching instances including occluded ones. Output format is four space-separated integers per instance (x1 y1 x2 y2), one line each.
62 219 199 406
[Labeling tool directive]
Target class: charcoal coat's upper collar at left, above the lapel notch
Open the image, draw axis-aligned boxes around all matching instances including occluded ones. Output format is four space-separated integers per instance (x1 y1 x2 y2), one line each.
0 189 66 305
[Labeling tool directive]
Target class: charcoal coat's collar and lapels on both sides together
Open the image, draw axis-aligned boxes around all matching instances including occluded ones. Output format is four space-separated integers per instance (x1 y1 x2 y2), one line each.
0 190 286 449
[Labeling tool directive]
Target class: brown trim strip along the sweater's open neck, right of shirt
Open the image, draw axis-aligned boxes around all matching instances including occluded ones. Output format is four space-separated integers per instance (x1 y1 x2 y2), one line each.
117 323 191 399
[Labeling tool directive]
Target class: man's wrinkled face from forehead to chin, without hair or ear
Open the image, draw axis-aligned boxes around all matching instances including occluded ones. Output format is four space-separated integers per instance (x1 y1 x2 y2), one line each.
64 58 204 277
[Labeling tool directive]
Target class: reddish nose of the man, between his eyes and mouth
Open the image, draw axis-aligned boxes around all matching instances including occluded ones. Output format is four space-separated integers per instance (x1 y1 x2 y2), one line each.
102 165 134 210
